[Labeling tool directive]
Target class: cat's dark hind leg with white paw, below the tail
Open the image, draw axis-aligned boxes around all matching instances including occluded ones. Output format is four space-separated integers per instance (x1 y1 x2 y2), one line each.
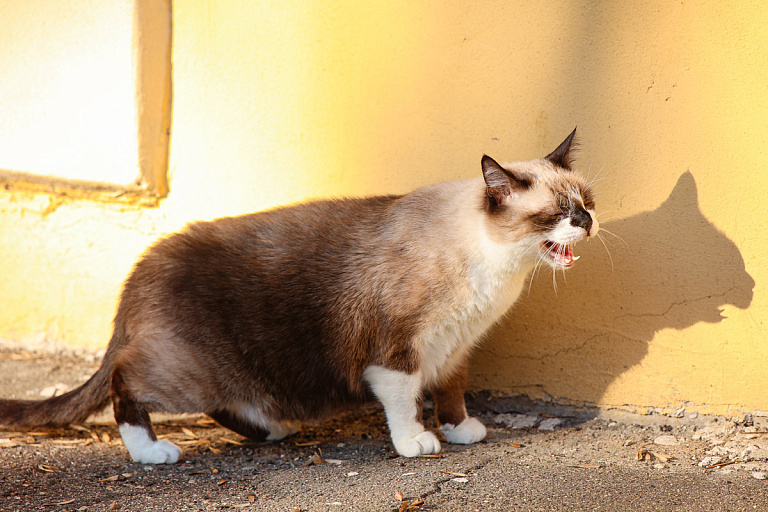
112 370 181 464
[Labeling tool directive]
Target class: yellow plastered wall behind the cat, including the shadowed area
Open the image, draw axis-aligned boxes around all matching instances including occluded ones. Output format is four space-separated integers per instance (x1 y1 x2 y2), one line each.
0 0 768 414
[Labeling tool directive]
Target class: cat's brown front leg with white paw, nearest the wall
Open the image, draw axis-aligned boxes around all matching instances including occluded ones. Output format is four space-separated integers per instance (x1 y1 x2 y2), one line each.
431 365 486 444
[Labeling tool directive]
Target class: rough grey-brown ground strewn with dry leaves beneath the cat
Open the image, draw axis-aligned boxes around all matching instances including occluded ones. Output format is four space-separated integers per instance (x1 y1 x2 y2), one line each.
0 349 768 512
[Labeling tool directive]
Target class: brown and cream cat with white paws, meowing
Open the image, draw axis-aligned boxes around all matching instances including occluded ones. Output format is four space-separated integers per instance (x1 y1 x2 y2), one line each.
0 130 599 464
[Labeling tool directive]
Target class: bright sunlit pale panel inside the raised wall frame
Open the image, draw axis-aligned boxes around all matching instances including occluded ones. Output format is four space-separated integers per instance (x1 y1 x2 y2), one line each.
0 0 140 185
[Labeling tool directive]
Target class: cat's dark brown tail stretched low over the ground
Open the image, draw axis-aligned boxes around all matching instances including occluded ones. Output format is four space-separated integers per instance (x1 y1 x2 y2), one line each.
0 328 125 429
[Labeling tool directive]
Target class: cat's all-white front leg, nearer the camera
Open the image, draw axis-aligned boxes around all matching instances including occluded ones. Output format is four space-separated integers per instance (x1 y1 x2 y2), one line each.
363 366 440 457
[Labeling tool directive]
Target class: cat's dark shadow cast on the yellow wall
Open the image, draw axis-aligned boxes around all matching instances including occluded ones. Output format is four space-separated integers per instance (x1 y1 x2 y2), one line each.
471 172 755 404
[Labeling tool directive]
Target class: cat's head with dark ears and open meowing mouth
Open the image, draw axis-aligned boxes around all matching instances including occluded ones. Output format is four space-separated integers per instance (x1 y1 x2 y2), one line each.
481 130 600 269
